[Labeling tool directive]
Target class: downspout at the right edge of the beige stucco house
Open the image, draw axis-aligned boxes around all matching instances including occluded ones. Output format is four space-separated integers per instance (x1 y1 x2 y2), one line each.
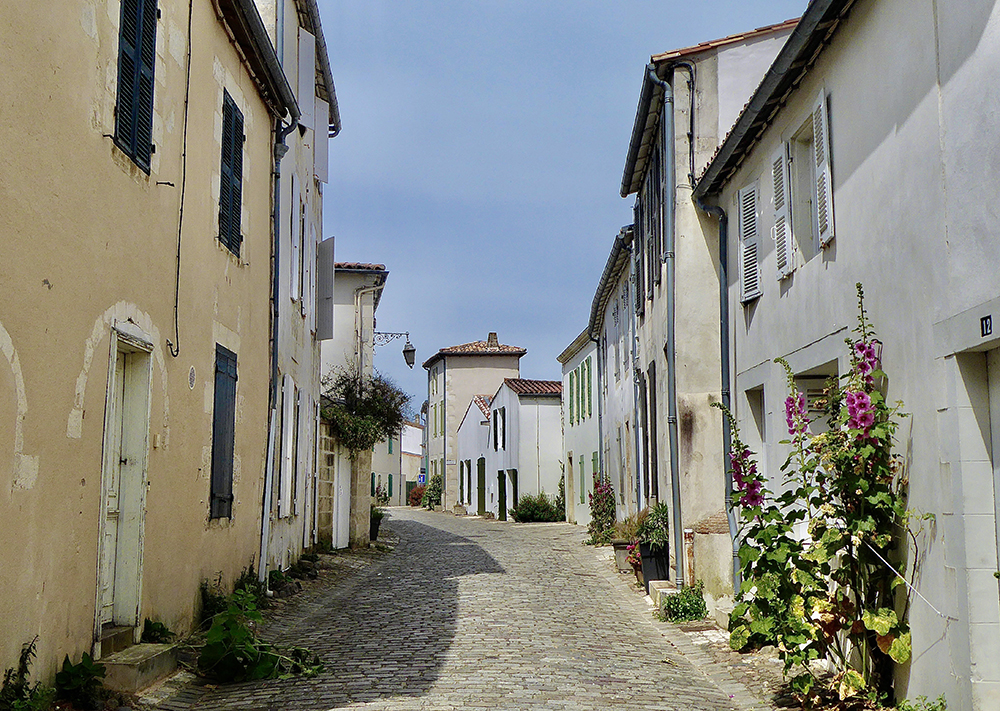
257 117 299 584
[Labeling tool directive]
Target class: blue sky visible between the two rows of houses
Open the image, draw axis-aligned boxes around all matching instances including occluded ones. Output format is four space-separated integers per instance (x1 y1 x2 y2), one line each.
319 0 806 408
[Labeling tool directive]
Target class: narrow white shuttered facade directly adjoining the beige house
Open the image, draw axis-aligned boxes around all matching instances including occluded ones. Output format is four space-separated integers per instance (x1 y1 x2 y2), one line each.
258 0 339 575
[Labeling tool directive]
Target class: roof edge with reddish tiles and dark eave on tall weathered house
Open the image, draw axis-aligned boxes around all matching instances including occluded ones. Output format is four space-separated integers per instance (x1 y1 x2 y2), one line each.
620 19 799 197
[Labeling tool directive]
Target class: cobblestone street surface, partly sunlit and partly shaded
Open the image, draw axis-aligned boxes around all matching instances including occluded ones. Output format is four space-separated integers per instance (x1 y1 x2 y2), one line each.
145 508 770 711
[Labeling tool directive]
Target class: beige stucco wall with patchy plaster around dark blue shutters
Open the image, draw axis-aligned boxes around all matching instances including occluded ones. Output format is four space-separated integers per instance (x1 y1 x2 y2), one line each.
0 0 271 679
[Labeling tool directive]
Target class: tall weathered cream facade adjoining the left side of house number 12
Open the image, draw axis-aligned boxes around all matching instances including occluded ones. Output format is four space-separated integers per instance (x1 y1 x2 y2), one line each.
621 22 794 597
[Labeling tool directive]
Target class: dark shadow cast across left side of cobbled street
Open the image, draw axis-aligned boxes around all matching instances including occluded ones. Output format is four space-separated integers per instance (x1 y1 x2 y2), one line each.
190 518 505 709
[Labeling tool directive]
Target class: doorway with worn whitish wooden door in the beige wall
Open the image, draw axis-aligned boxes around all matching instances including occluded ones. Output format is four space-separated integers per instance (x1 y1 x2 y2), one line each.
96 329 152 653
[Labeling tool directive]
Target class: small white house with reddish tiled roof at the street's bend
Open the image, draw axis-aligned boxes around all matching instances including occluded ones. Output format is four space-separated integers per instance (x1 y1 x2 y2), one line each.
486 379 562 520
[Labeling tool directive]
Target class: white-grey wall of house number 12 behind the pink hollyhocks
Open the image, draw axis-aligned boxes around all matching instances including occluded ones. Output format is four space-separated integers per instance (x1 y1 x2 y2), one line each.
709 0 1000 711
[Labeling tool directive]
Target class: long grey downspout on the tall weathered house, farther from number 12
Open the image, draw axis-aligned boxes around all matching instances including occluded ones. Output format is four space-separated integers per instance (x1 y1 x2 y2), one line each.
647 64 684 587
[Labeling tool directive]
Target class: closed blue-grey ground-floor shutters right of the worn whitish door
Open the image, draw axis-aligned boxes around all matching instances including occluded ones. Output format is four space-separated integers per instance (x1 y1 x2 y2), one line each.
209 344 236 518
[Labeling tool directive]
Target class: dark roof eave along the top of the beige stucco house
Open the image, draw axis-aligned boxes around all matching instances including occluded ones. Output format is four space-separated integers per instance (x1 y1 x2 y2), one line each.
218 0 300 119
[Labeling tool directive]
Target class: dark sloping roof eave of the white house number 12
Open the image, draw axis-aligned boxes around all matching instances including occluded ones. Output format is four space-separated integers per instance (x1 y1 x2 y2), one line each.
693 0 854 199
